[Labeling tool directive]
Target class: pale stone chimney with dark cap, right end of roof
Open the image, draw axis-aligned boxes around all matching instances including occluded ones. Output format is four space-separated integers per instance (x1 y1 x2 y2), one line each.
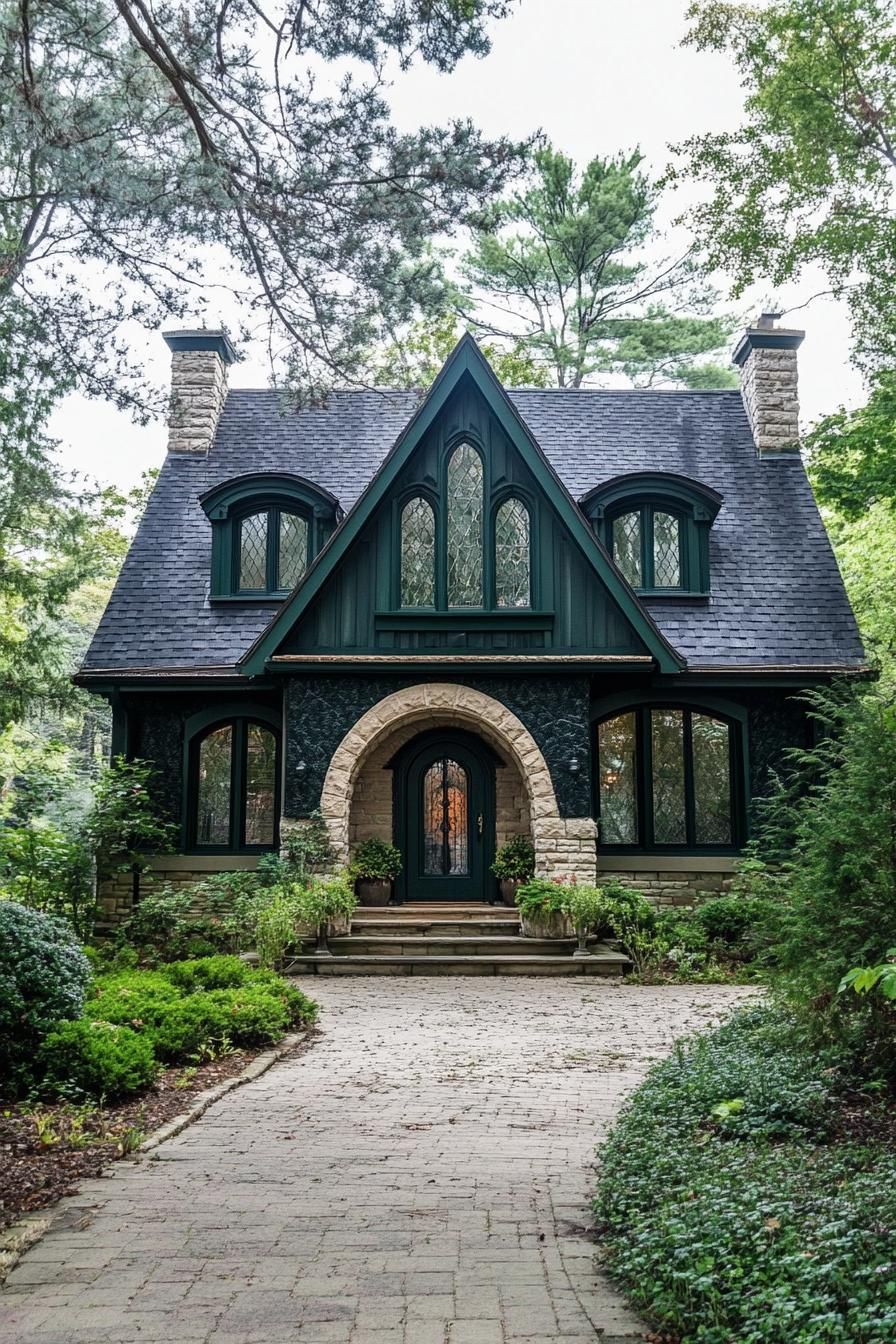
732 313 806 457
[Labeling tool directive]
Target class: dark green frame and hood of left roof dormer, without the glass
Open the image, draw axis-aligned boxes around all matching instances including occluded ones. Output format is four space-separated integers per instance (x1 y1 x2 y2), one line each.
199 472 341 603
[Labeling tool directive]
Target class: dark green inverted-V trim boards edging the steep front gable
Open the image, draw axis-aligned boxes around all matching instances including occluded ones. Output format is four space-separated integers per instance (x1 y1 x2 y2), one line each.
240 336 684 676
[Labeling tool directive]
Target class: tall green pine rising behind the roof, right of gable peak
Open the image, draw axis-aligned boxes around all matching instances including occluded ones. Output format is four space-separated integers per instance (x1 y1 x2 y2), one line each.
458 148 735 387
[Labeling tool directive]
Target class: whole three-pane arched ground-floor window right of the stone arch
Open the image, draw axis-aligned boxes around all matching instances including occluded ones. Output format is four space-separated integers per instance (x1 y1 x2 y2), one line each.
598 706 742 849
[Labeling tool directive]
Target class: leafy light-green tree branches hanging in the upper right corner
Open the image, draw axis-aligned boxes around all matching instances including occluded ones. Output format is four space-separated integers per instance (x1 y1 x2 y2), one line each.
672 0 896 367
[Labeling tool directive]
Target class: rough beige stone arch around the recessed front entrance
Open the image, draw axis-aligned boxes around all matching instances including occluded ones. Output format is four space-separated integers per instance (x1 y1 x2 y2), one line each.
320 681 596 880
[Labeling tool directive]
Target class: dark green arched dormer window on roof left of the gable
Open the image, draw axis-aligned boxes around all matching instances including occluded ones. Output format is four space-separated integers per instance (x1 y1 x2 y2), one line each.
200 473 340 601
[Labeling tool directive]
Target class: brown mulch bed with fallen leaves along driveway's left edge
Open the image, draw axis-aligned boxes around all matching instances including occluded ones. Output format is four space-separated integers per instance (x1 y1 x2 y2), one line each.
0 1046 294 1231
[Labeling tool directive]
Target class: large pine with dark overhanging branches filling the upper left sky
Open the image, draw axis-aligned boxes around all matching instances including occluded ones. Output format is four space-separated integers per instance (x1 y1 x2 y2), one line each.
0 0 519 413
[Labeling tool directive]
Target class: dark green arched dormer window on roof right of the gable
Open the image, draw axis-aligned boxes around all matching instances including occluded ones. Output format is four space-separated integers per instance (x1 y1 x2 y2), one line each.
582 472 721 597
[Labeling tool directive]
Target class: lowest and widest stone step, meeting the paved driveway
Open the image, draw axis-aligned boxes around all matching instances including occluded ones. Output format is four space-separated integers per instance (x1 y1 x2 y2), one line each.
286 949 629 977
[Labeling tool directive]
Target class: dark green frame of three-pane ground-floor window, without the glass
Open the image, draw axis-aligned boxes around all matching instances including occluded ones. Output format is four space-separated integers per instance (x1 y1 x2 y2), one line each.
592 696 748 855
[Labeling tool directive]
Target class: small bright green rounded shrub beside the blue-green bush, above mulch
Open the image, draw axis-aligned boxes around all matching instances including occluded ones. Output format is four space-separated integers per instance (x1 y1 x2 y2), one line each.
38 1020 159 1101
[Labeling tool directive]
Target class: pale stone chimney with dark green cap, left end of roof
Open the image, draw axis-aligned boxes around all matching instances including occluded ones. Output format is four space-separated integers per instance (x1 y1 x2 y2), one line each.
163 328 236 453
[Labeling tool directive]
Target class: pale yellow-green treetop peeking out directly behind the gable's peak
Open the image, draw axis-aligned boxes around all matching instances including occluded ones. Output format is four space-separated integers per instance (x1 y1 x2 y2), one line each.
373 312 549 388
